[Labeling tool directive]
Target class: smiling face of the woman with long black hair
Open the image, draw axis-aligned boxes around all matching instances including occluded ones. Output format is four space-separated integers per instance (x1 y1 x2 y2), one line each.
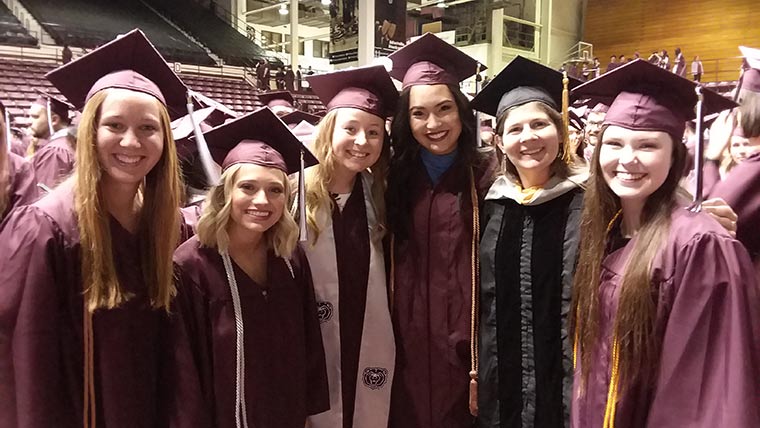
409 85 462 155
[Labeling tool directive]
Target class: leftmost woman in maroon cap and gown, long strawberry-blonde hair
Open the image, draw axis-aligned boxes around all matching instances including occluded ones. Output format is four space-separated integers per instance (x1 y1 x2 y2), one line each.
0 30 185 428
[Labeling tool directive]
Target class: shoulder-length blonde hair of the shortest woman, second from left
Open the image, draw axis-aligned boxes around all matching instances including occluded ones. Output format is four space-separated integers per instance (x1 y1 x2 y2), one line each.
197 164 298 258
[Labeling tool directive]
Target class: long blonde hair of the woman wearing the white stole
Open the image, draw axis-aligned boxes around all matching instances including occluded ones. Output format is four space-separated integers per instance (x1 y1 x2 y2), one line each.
306 109 390 243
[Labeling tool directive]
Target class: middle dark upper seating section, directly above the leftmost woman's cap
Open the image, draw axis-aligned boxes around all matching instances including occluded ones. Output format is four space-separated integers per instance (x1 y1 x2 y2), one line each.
23 0 216 65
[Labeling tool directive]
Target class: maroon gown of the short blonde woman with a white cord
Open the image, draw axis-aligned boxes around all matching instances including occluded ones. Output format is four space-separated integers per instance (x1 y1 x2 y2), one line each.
173 237 329 428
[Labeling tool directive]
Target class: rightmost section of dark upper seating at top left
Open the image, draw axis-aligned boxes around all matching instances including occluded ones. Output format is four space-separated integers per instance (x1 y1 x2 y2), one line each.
148 0 266 67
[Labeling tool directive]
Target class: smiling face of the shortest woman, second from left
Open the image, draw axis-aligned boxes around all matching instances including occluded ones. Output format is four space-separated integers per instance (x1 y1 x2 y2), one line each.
227 164 287 236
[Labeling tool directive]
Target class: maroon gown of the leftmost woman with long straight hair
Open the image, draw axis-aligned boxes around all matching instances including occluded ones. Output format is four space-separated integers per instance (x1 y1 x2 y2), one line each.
0 186 174 428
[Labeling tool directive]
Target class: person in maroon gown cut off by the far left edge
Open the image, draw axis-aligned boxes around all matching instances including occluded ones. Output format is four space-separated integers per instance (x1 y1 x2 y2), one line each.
0 102 38 222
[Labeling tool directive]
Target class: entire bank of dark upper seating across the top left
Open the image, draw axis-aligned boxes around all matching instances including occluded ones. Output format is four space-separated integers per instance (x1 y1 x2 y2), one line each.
0 0 274 67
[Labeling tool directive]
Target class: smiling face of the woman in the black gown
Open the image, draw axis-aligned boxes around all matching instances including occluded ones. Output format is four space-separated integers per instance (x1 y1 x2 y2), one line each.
501 102 560 184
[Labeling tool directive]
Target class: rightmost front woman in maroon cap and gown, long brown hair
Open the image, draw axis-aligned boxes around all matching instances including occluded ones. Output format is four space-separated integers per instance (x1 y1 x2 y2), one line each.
571 58 760 428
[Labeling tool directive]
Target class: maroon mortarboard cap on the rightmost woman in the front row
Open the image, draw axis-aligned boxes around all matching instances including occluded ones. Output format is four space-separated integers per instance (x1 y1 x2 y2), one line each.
575 59 737 141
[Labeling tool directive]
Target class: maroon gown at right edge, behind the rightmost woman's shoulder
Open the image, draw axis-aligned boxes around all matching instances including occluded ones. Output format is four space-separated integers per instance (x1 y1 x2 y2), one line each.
710 152 760 260
